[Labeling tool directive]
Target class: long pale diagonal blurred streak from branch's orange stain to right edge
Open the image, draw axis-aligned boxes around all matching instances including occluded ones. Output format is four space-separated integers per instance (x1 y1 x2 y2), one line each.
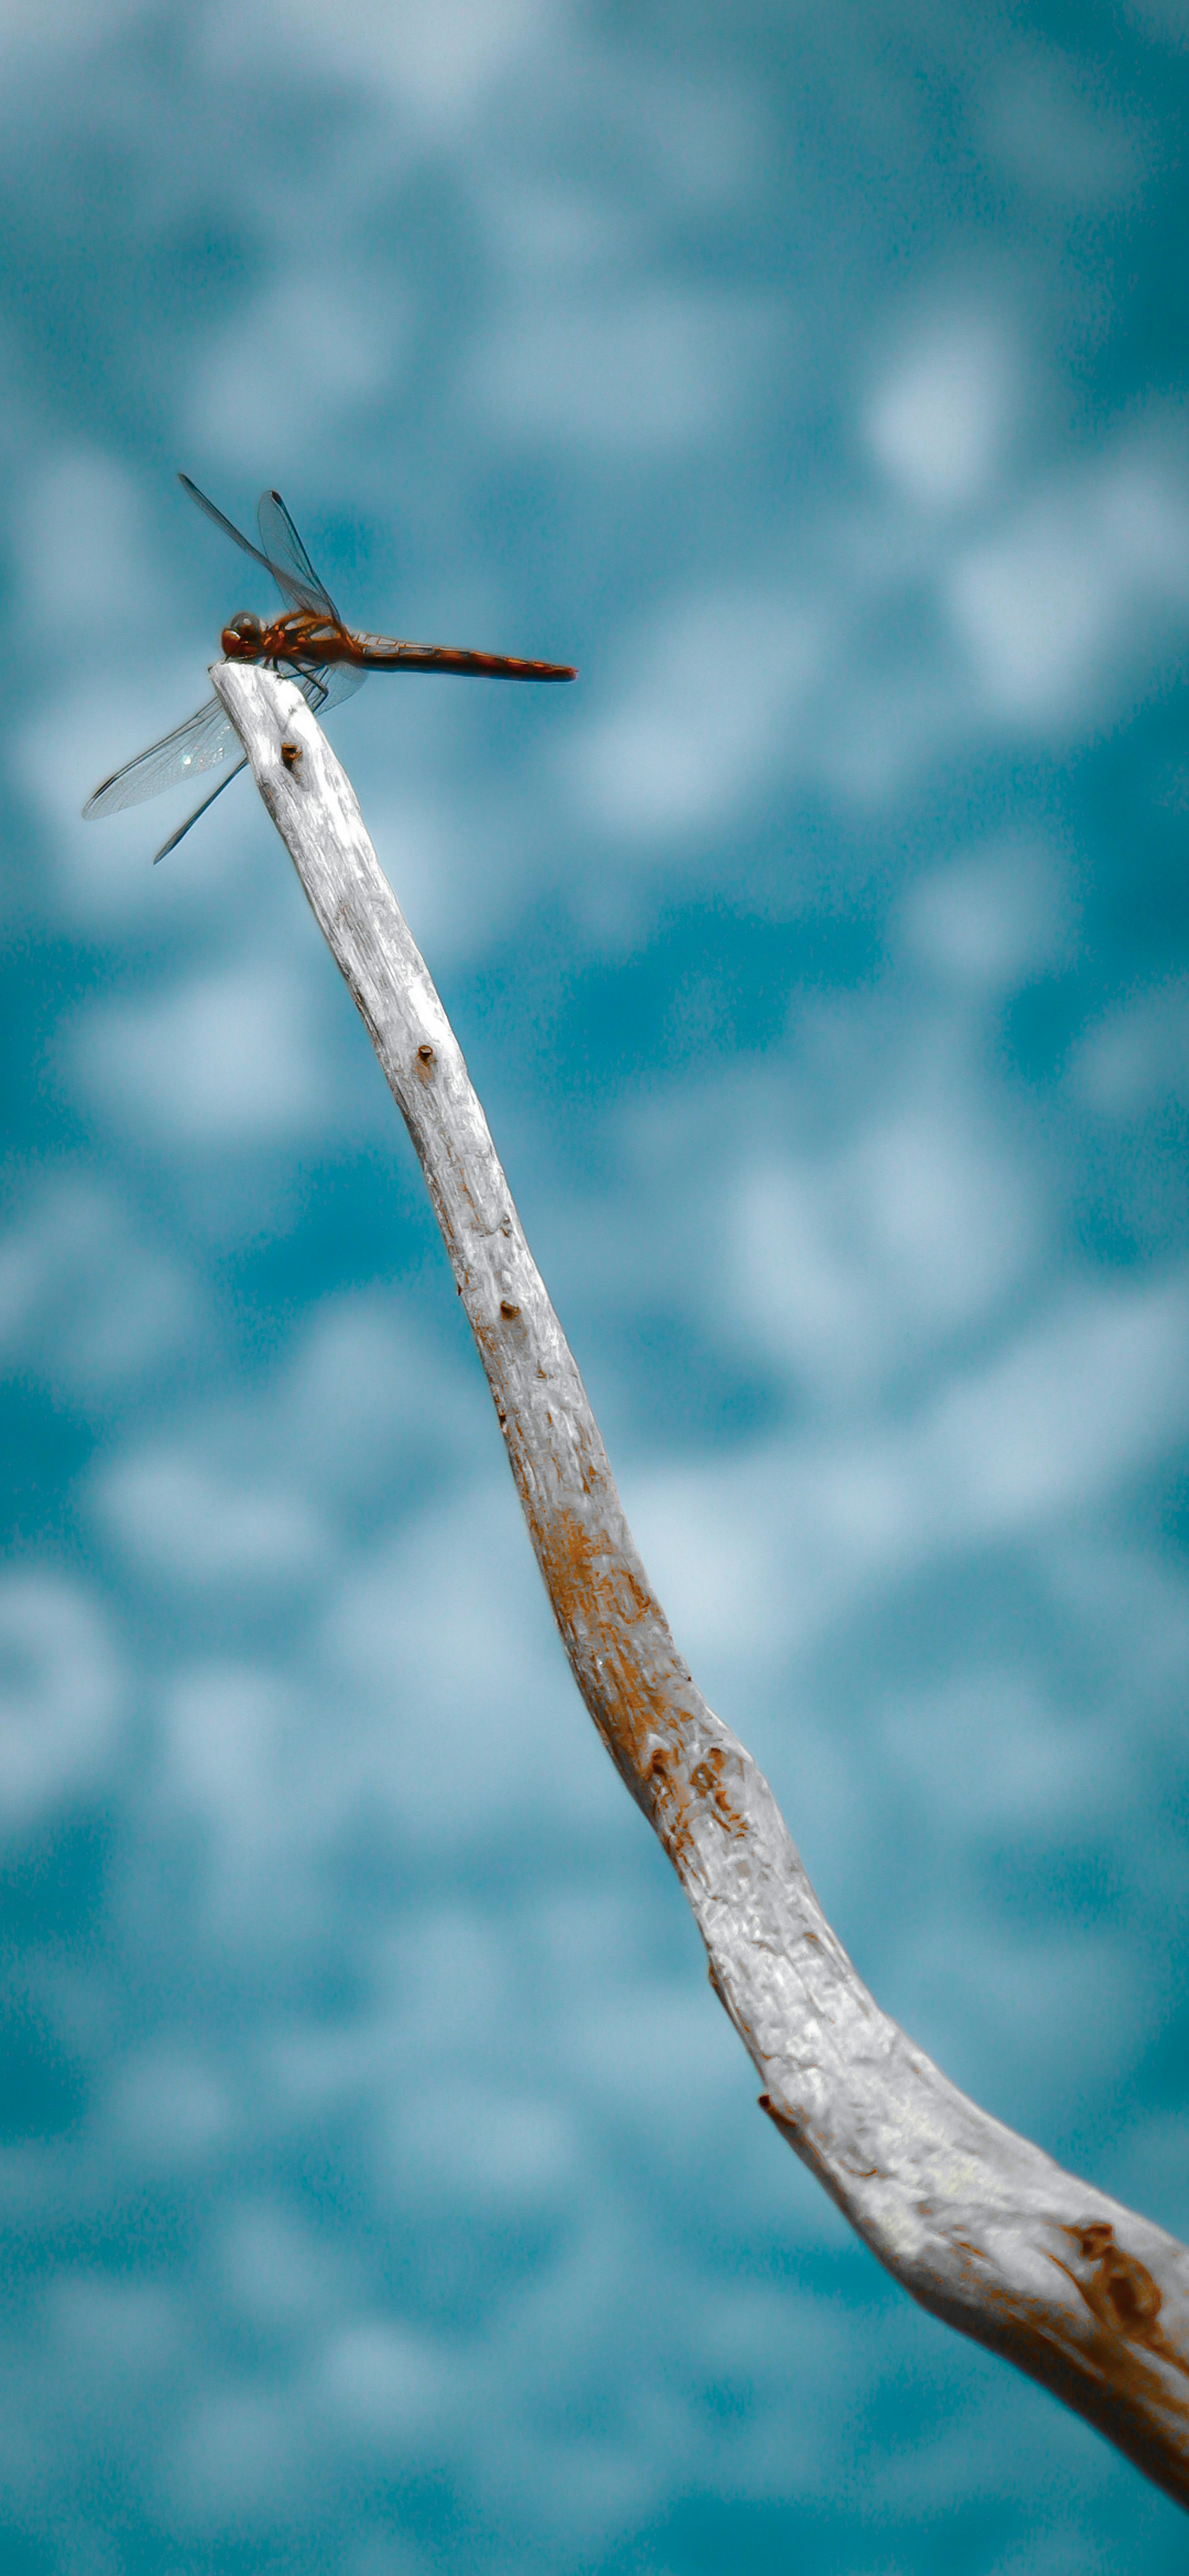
631 1275 1189 1685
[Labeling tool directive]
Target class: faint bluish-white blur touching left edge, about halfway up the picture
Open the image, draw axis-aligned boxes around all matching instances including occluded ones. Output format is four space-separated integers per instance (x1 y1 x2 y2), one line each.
0 1177 198 1394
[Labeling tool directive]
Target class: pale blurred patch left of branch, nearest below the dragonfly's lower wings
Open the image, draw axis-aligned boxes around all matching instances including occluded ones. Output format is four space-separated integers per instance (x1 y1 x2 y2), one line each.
75 963 335 1146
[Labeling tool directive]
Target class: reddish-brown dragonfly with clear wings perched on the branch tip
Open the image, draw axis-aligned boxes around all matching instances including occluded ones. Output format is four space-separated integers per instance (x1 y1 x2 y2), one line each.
82 474 576 866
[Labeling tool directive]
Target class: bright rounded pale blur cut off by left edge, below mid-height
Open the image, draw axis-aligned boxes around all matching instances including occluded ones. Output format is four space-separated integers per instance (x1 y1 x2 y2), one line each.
0 1571 124 1829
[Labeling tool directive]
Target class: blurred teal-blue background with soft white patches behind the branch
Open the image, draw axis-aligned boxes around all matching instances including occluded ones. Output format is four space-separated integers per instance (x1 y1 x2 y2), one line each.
0 0 1189 2576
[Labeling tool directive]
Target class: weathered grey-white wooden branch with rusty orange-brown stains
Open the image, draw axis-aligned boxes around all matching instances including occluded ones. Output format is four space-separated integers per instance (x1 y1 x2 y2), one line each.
211 662 1189 2504
